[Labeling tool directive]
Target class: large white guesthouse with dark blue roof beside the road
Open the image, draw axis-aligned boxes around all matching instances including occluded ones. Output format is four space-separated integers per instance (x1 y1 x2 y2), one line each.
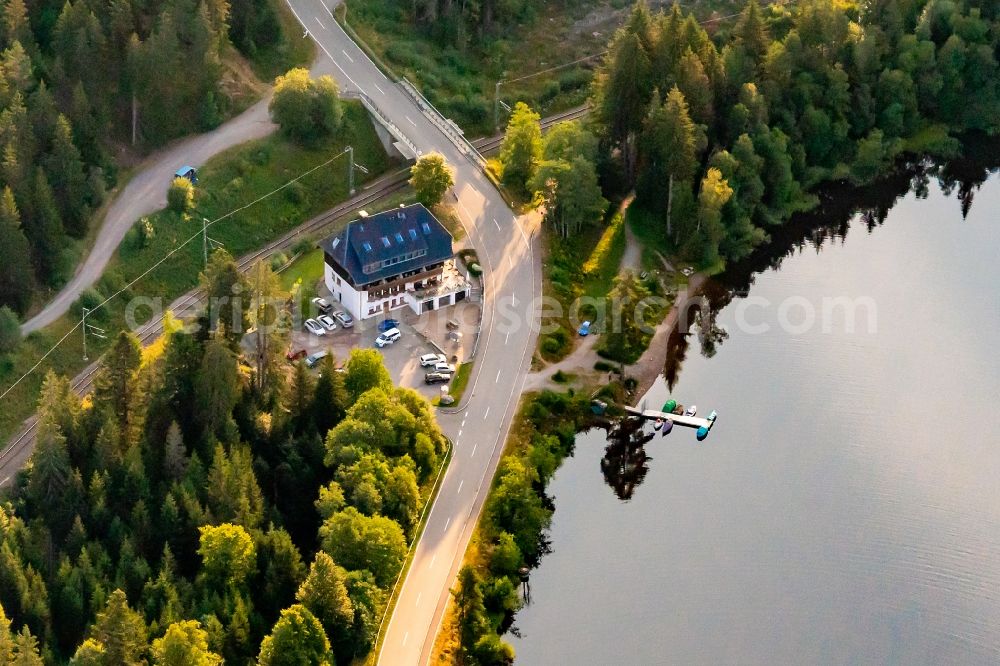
320 204 470 319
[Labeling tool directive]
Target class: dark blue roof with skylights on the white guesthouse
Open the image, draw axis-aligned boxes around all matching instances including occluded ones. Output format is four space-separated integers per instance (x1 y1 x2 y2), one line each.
320 204 453 286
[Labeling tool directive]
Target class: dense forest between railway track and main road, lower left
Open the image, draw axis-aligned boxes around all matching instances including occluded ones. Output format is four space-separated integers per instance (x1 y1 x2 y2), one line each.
0 251 447 666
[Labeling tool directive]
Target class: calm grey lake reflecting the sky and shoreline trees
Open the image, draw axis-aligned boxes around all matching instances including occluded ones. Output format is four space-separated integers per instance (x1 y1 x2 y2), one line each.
508 153 1000 665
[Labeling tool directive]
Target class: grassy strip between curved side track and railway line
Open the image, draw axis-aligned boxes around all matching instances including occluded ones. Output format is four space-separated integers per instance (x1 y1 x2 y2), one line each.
0 104 390 440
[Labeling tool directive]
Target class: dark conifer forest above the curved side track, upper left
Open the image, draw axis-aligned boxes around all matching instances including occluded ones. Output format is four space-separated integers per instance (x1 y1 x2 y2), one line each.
0 0 302 315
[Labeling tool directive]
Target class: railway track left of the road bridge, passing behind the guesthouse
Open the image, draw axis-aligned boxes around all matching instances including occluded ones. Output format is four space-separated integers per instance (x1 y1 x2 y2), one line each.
0 169 409 487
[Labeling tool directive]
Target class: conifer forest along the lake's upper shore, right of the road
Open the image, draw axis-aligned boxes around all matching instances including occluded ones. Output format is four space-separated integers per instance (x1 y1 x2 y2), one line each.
593 0 1000 266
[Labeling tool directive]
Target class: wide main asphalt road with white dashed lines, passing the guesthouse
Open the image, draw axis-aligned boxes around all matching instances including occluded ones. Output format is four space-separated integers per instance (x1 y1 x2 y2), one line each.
288 0 541 666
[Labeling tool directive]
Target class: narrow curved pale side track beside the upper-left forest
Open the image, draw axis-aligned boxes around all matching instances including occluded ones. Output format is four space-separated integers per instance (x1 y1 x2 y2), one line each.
21 53 352 335
